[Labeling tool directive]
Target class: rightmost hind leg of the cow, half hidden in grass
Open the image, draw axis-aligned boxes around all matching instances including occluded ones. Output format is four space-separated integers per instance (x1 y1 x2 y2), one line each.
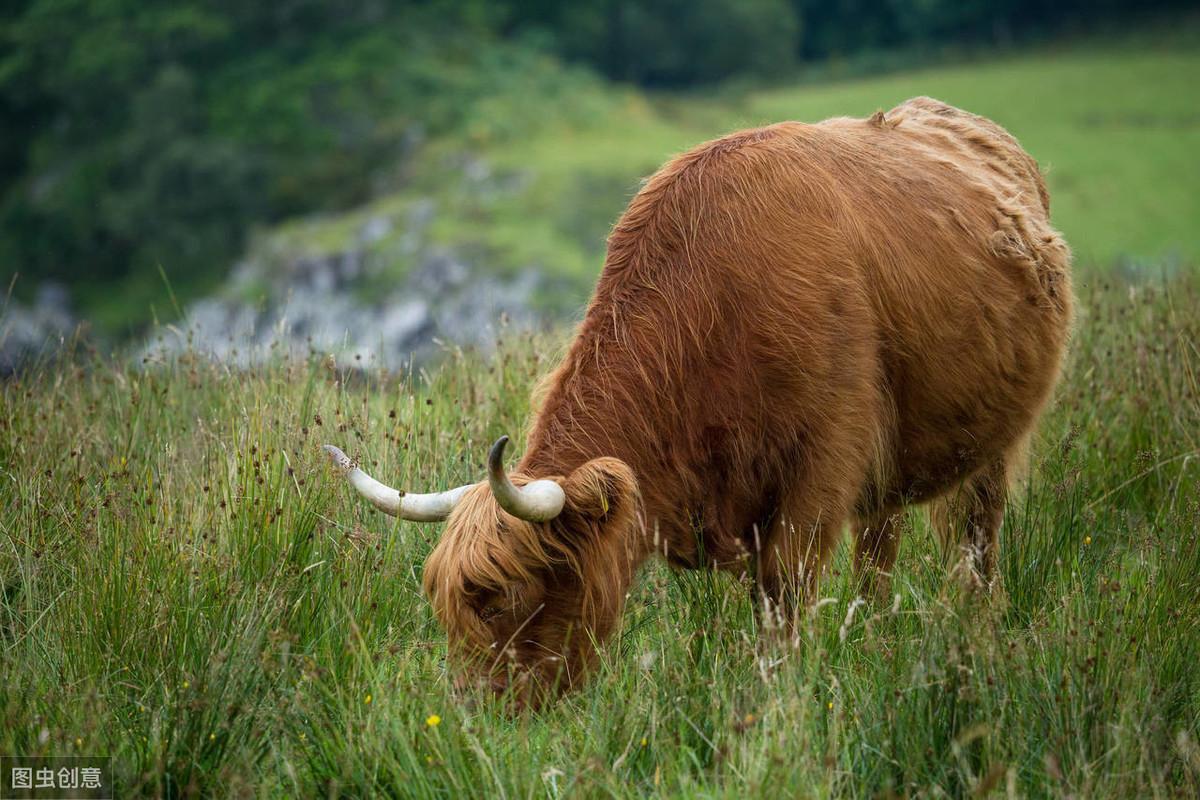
932 458 1009 585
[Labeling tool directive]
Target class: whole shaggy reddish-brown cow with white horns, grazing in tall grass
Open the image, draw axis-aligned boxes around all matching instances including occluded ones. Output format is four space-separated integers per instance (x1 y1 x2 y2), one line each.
330 97 1072 703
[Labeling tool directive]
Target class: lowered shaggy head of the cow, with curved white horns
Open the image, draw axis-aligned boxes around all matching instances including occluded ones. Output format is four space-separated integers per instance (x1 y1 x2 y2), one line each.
326 437 638 706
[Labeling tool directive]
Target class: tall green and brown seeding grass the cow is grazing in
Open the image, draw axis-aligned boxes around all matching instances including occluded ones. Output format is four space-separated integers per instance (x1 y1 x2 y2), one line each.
0 273 1200 798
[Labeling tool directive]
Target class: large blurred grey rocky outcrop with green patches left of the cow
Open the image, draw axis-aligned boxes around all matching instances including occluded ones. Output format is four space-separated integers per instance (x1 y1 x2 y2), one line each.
142 188 544 368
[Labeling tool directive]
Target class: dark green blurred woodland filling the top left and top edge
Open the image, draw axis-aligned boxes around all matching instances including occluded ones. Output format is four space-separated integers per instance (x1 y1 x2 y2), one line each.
0 0 1185 326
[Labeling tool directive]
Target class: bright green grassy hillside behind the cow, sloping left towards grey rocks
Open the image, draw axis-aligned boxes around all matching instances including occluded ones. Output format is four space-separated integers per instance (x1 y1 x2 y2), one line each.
260 19 1200 311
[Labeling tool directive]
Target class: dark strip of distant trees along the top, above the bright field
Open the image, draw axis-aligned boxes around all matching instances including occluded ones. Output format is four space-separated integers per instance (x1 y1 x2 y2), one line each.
506 0 1184 86
